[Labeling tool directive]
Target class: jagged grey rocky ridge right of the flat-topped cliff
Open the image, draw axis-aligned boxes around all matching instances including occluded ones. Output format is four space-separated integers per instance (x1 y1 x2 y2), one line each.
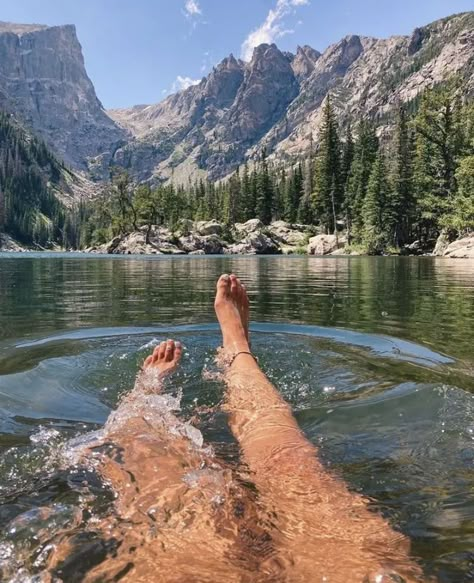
107 12 474 183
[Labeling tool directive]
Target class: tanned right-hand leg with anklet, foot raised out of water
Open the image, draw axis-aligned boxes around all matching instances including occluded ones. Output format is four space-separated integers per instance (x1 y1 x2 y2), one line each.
215 275 421 582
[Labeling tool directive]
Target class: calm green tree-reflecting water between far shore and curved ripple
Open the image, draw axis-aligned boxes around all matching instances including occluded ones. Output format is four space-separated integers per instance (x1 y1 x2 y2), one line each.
0 255 474 357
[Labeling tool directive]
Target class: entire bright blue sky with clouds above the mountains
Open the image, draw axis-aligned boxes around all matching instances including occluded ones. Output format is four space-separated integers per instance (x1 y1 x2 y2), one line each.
0 0 473 108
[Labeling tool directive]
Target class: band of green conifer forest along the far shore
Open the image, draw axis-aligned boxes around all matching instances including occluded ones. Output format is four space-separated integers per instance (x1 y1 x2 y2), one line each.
0 83 474 253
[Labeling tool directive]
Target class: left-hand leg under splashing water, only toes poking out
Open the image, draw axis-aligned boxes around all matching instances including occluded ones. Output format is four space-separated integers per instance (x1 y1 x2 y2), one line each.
51 340 279 583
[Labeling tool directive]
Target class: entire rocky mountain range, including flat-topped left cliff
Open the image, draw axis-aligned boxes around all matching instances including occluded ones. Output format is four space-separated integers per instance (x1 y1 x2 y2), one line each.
0 12 474 183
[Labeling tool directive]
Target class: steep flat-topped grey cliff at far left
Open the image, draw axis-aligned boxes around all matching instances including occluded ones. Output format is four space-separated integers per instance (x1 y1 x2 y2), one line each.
0 23 125 169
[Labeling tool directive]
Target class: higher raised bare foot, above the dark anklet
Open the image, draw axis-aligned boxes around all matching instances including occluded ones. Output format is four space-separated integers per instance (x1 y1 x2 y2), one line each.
214 275 250 354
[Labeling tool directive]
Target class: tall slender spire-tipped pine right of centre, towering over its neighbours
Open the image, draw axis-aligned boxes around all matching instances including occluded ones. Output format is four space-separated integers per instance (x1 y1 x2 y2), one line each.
313 96 342 233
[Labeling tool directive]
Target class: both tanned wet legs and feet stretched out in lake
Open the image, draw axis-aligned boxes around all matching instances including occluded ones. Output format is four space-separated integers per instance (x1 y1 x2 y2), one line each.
51 275 423 583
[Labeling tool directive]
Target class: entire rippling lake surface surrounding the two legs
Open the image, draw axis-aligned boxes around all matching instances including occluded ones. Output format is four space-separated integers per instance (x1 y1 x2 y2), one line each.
0 255 474 582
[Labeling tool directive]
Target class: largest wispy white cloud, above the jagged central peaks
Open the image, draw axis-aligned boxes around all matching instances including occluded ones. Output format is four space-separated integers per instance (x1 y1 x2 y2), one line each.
241 0 309 61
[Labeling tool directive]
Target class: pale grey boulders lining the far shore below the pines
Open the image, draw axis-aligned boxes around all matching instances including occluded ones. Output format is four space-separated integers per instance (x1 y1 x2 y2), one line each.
0 219 474 259
